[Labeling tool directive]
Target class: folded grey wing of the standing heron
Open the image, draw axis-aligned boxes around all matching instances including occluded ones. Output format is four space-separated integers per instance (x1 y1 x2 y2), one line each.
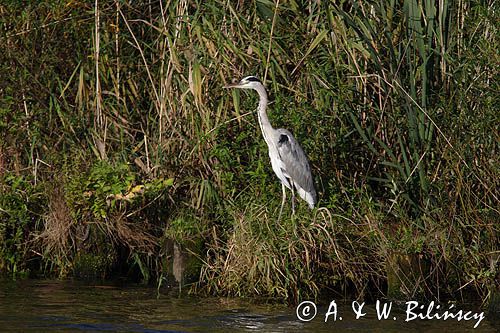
277 128 316 198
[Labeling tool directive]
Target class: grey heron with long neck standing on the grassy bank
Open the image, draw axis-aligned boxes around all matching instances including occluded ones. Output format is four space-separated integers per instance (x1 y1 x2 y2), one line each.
224 76 317 219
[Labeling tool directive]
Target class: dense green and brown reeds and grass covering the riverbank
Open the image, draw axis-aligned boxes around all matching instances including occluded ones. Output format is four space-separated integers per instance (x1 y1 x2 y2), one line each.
0 0 500 302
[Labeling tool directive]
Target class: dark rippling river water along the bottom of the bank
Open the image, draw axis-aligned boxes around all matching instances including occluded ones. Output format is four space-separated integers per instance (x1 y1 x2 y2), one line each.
0 280 500 333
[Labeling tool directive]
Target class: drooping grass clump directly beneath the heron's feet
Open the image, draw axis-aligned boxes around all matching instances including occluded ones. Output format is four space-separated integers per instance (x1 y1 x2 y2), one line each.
198 206 384 303
